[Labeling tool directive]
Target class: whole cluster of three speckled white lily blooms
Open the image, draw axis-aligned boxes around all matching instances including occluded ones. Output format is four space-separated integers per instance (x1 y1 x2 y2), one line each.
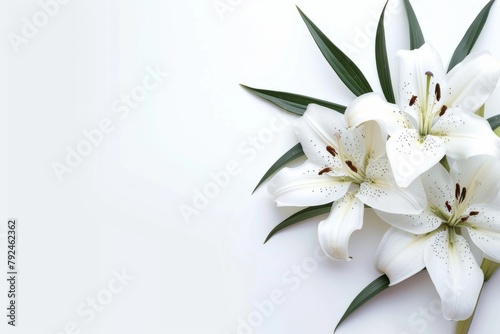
268 43 500 320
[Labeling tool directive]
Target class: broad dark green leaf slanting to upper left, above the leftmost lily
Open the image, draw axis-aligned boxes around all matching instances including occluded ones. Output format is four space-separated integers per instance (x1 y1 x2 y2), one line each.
297 7 373 96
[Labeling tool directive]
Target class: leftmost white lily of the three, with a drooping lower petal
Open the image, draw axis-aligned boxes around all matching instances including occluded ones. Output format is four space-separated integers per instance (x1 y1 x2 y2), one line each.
268 104 426 259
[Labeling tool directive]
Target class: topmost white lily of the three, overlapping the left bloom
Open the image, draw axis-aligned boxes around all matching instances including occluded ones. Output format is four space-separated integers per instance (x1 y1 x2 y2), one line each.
346 43 500 187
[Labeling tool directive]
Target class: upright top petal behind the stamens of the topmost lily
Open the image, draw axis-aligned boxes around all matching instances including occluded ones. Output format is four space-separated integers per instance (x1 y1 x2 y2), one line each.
396 43 446 120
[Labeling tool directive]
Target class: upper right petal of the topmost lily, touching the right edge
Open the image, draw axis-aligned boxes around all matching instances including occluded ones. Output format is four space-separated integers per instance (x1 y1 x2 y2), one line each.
444 51 500 112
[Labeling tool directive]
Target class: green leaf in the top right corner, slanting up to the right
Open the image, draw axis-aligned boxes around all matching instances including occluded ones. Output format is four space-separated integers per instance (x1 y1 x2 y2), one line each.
448 0 495 72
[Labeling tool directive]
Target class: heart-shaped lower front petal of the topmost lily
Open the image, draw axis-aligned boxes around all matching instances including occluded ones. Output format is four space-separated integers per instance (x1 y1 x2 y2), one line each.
387 129 446 187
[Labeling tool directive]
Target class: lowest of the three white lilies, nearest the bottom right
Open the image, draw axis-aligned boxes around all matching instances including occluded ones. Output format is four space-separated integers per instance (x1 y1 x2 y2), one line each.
375 156 500 320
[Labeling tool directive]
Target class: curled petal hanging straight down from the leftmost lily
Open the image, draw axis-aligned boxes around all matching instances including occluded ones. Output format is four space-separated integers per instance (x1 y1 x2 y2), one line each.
318 192 364 260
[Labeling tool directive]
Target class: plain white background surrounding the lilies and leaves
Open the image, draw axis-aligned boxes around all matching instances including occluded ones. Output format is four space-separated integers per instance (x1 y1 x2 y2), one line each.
0 0 500 334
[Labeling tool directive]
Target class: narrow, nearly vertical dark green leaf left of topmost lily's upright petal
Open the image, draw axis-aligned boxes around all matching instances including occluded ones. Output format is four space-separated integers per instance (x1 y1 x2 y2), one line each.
375 1 396 103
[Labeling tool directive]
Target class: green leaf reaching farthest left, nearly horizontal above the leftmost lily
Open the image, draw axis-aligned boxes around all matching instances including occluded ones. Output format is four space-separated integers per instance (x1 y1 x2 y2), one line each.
240 85 346 116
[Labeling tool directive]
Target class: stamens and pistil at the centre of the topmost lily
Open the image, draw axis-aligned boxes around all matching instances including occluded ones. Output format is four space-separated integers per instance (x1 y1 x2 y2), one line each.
408 71 448 138
